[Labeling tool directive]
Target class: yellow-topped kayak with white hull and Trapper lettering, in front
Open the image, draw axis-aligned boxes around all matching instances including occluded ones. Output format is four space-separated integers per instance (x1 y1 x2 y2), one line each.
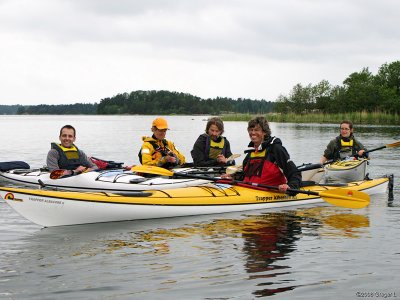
0 178 388 227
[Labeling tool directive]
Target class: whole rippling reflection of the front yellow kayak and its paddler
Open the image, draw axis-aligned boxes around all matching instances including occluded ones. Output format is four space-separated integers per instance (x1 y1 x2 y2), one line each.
2 207 369 297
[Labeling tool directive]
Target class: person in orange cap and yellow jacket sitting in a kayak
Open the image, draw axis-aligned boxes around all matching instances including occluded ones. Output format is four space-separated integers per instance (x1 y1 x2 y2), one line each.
139 118 185 169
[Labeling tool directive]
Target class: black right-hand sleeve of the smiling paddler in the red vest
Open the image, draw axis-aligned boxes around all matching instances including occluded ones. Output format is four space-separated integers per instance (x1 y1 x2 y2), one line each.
272 144 301 189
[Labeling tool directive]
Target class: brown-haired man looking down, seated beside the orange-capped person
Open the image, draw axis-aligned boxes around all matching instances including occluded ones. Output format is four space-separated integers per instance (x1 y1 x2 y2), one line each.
190 117 235 167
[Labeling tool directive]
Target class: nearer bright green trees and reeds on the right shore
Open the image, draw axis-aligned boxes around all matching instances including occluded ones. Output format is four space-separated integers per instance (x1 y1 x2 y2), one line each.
275 61 400 115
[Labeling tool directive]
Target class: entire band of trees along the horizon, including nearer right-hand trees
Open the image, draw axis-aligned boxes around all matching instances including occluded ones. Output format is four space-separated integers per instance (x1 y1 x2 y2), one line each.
0 61 400 119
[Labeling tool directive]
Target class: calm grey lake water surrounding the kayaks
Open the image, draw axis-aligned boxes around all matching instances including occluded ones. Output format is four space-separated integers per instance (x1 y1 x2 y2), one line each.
0 116 400 299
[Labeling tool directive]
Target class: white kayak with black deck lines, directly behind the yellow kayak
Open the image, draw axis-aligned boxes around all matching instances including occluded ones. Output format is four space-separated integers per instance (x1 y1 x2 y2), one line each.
0 169 210 192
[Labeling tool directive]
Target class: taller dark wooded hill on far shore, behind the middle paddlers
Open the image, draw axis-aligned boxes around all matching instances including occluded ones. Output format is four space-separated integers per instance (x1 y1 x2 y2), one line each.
97 91 275 115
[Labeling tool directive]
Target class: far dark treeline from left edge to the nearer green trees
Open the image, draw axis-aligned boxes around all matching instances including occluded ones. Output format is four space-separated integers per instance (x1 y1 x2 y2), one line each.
0 91 275 115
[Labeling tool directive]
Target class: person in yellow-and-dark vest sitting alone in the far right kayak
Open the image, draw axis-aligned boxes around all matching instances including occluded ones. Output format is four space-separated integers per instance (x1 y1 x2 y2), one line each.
321 120 368 164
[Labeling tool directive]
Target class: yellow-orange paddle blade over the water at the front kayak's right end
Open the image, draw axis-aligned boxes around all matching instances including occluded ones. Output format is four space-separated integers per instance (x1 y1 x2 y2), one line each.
319 188 371 208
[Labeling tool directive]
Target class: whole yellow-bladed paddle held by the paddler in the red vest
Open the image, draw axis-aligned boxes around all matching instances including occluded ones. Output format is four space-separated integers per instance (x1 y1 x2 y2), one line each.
132 166 370 208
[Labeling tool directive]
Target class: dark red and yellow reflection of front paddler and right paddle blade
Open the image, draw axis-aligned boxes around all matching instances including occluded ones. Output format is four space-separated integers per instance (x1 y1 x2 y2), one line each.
242 208 369 297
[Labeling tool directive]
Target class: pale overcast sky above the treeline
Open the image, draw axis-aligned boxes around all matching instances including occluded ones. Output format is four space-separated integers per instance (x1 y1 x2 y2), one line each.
0 0 400 104
